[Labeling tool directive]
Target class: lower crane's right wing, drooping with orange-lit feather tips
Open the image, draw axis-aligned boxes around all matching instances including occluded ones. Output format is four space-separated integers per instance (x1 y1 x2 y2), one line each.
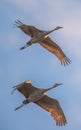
34 95 66 126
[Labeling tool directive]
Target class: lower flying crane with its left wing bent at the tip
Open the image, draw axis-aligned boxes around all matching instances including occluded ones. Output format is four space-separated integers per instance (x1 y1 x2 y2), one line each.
12 80 67 126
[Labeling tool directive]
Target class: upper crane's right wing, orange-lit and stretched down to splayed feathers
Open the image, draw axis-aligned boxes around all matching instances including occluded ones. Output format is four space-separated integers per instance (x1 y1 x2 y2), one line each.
39 37 71 66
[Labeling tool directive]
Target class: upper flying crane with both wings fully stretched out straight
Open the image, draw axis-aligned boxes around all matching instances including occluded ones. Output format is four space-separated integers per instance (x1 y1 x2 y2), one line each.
14 20 71 66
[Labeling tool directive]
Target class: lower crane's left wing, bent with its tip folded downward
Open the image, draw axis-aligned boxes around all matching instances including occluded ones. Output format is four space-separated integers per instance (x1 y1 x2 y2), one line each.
12 82 38 98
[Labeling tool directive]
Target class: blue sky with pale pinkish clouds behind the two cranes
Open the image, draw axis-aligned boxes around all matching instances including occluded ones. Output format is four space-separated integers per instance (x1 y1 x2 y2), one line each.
0 0 81 130
